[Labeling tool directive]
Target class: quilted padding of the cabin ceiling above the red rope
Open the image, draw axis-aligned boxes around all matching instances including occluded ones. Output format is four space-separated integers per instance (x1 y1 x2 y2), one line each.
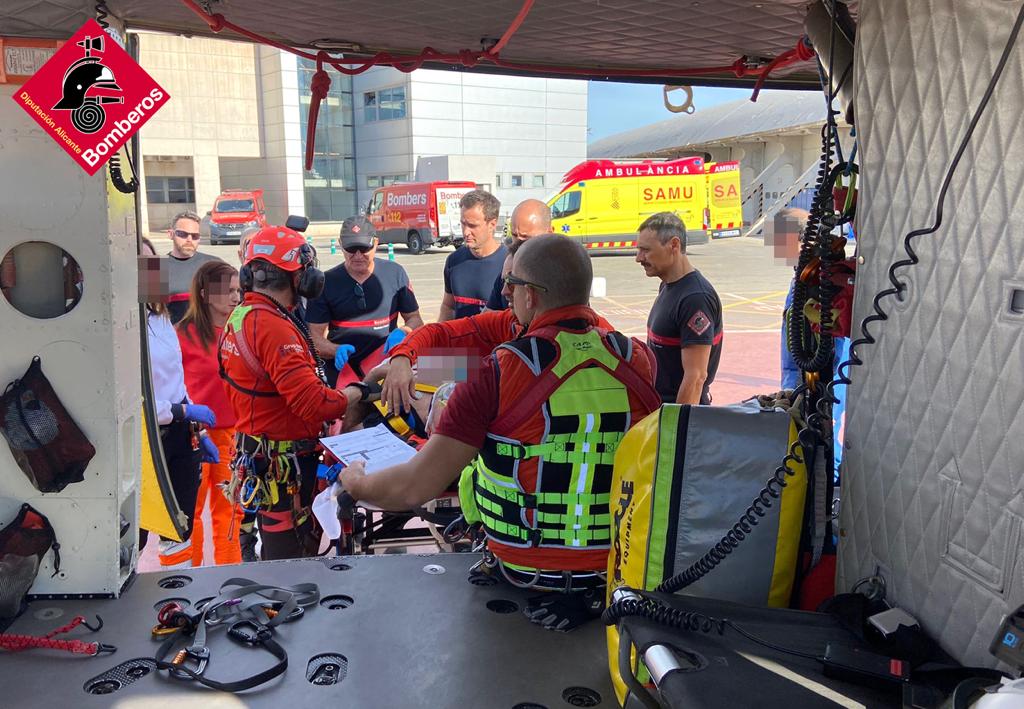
0 0 831 87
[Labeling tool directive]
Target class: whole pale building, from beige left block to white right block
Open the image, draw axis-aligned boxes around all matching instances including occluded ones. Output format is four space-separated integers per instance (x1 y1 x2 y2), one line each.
133 34 588 233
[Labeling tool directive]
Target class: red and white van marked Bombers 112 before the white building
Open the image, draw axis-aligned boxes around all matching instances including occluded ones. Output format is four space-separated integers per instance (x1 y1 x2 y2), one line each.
367 182 476 254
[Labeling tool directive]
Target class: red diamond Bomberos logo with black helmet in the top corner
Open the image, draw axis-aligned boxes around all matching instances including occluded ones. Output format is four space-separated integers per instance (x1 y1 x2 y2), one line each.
13 19 170 175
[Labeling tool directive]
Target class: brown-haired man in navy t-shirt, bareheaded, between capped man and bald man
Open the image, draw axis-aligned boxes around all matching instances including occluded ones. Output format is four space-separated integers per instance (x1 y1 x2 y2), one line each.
437 190 507 323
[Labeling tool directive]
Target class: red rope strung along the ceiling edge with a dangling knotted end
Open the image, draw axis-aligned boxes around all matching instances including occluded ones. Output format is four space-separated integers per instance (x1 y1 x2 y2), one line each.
181 0 814 170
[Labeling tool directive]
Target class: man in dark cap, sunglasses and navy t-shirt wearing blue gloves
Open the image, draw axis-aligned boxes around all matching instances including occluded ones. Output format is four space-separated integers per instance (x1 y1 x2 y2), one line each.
306 217 423 386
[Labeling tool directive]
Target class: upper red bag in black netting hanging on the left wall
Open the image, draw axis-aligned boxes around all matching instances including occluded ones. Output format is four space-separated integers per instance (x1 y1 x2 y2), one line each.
0 357 96 493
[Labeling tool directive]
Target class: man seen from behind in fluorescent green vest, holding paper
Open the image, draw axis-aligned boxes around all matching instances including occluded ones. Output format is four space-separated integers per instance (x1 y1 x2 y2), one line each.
339 235 660 630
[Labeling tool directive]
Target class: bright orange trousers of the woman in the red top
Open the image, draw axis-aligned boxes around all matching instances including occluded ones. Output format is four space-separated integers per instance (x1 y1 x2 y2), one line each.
191 428 242 567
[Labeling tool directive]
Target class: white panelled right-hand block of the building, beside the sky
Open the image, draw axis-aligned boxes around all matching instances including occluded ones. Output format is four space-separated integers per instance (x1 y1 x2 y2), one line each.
352 67 588 216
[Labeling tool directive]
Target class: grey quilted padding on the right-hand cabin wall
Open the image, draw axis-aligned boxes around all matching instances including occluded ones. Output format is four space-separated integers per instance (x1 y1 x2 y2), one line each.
839 0 1024 665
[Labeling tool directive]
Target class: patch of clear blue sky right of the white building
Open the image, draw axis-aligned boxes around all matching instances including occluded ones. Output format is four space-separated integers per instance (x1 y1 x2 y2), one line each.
587 81 751 142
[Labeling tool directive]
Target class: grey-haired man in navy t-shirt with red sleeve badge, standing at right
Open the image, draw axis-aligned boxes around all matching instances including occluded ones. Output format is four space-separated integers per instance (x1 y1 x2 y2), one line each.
637 212 722 404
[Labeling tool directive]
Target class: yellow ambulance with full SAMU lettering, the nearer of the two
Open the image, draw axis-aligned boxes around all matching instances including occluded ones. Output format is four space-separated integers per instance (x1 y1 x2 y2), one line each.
548 158 708 249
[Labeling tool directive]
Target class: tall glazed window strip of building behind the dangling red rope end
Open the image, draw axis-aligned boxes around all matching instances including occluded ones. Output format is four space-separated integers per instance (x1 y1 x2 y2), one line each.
297 57 358 221
